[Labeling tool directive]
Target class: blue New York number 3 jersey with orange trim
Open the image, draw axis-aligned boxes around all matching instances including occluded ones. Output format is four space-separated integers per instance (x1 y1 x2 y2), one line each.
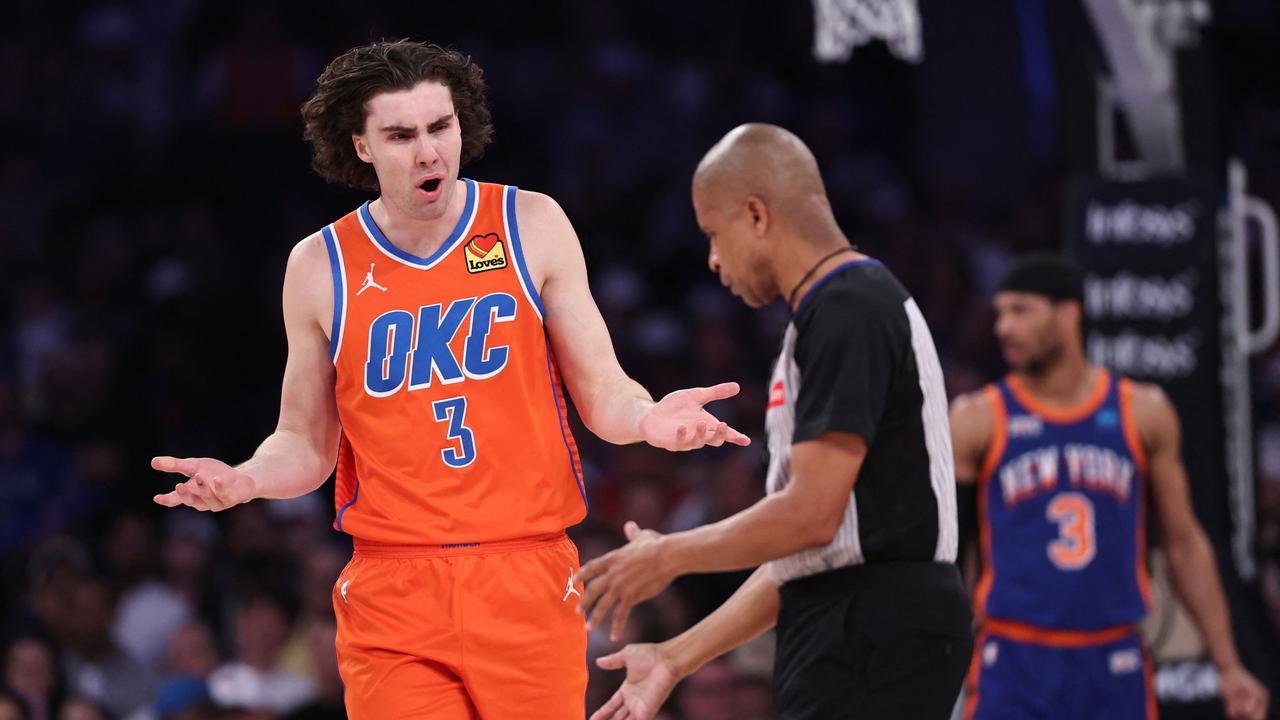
975 370 1149 632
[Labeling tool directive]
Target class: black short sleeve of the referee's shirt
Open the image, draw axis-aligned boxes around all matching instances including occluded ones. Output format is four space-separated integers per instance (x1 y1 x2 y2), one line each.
792 295 901 445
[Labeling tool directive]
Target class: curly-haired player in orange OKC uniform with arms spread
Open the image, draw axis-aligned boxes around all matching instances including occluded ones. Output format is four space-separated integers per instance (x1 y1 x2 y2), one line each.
152 41 749 720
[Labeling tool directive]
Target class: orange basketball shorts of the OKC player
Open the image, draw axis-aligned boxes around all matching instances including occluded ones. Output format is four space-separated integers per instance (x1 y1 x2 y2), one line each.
333 533 586 720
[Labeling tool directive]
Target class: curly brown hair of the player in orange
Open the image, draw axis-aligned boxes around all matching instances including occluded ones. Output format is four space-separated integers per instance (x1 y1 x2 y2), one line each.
302 40 493 190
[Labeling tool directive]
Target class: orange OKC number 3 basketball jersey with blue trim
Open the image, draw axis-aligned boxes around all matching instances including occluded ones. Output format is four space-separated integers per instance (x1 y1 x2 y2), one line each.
323 179 586 544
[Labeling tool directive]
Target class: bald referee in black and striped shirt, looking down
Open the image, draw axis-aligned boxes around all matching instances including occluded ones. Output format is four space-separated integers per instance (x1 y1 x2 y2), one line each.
577 124 973 720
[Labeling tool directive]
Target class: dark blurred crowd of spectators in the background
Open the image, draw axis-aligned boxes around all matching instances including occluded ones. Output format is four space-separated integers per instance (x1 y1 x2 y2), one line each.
0 0 1280 720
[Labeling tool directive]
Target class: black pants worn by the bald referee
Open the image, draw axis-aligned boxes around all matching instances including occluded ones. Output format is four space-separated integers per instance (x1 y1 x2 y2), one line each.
773 562 973 720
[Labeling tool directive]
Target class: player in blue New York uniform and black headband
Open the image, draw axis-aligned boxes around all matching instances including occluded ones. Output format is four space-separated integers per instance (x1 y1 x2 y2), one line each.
951 255 1267 720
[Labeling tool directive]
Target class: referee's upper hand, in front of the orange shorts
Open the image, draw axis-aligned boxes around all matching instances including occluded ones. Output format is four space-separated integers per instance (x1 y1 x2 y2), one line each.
573 520 676 642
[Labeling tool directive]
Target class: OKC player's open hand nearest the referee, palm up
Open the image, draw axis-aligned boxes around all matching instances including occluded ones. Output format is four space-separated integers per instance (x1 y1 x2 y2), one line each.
640 383 751 450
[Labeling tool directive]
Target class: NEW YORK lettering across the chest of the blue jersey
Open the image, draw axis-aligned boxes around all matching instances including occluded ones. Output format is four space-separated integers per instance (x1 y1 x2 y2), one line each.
1000 443 1137 507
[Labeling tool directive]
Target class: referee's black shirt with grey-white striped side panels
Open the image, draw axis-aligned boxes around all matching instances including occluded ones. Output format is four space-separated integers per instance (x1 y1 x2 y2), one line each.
765 260 957 582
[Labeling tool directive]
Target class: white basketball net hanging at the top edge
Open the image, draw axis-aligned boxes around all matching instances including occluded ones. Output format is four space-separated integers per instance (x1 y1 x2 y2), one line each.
813 0 924 63
